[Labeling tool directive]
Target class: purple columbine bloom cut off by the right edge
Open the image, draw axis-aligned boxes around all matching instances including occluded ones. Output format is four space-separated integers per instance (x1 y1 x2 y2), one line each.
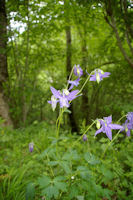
121 112 133 137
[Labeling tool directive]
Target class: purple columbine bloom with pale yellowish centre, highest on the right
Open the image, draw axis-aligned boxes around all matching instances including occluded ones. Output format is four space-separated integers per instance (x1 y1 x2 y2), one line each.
90 69 110 83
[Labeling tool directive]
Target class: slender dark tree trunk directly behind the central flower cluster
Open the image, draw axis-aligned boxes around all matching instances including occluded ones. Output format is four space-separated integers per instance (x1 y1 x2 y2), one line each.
66 26 78 132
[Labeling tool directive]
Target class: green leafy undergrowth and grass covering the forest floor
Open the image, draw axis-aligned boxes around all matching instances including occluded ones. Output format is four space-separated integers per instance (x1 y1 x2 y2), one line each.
0 123 133 200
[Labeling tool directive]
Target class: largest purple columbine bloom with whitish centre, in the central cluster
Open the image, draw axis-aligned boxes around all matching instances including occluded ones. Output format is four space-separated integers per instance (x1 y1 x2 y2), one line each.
48 87 79 108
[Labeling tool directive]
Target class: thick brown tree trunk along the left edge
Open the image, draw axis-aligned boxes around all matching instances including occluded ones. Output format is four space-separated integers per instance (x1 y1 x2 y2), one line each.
0 0 12 126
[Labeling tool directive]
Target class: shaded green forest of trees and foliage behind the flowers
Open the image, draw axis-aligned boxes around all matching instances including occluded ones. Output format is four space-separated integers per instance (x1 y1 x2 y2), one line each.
0 0 133 131
